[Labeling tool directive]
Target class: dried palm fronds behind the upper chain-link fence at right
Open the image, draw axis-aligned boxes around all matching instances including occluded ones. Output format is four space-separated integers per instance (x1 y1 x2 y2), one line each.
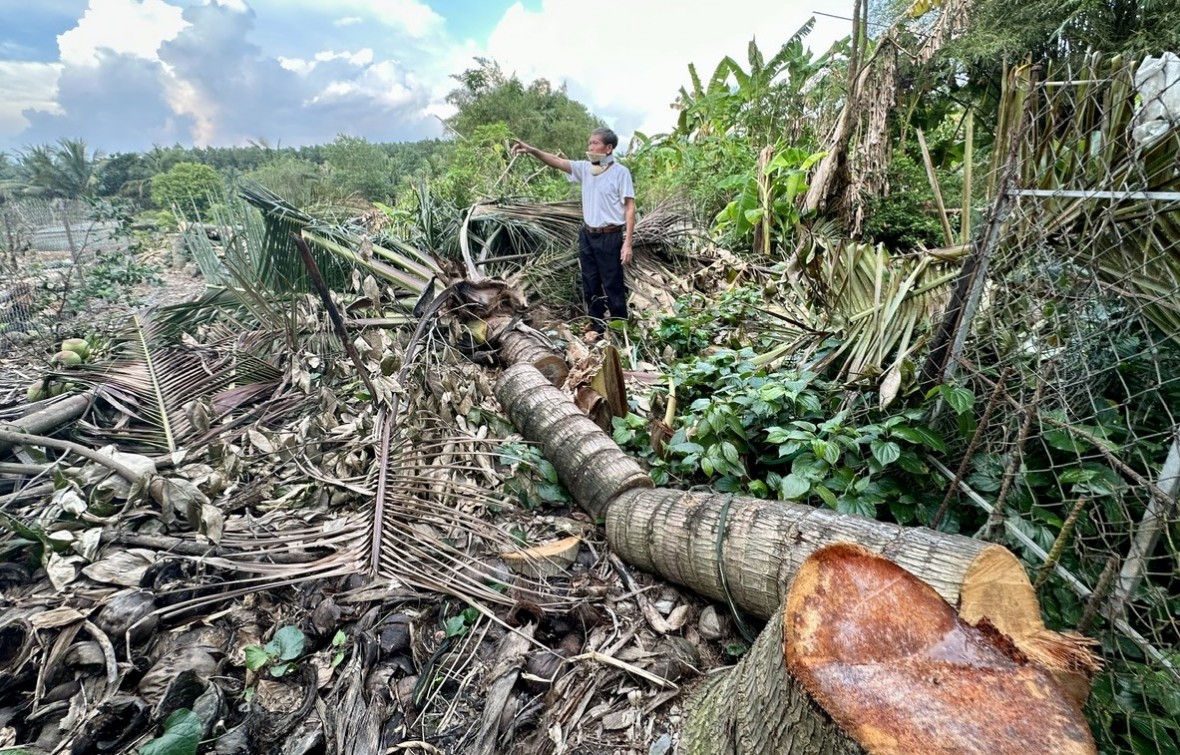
1004 54 1180 340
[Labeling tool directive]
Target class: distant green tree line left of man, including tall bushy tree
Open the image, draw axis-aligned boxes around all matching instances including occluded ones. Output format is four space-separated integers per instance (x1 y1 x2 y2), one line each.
0 59 602 226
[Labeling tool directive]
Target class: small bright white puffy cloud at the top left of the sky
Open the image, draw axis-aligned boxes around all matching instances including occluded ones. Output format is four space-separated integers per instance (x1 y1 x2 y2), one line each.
58 0 188 65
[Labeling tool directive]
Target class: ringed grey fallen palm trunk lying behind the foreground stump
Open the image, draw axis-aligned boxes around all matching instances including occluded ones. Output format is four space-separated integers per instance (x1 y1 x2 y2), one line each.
496 365 1023 619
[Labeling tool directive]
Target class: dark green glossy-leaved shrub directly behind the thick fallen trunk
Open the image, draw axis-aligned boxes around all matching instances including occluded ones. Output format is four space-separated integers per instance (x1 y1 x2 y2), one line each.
614 349 972 526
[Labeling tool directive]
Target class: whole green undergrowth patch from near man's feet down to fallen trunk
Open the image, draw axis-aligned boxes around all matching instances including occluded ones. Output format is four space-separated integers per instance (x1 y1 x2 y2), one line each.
614 281 974 531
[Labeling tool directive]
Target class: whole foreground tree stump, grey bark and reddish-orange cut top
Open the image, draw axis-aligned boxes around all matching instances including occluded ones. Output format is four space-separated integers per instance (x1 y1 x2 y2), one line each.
681 544 1096 755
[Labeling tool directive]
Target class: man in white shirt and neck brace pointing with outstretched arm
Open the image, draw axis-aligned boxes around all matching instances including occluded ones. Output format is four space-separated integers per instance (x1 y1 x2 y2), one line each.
512 129 635 339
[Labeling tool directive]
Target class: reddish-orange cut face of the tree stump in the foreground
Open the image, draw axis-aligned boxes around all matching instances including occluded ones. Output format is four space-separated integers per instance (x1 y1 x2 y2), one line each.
782 544 1095 755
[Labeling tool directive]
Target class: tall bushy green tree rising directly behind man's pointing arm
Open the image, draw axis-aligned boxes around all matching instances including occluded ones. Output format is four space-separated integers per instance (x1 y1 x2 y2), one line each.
446 58 605 156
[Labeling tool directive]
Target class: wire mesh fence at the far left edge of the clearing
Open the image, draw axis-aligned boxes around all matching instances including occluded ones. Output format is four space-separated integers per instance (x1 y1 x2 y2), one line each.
0 199 126 348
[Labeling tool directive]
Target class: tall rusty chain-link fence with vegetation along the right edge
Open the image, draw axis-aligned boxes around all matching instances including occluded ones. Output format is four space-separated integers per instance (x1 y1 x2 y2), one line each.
927 58 1180 753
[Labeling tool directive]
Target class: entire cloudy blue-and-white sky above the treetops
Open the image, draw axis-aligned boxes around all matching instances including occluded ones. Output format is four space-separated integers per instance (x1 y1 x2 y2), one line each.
0 0 852 153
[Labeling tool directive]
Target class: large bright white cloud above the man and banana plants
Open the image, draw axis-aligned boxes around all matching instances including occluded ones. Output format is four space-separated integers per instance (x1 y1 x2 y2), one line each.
487 0 852 133
